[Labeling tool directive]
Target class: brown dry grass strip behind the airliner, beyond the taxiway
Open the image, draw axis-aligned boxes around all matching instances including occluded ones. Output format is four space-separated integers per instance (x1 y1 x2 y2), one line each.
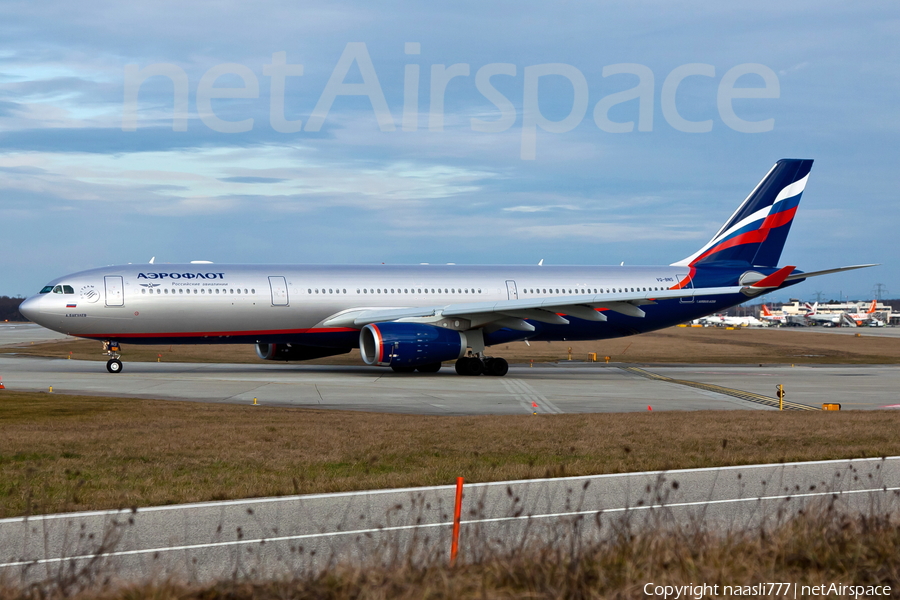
0 327 900 365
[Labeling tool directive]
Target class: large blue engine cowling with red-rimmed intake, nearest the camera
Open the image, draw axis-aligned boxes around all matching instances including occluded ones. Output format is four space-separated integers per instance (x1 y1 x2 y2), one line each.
359 323 468 367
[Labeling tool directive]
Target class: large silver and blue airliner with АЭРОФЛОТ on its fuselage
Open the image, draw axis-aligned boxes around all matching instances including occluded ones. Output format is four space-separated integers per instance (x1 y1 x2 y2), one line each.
19 159 874 376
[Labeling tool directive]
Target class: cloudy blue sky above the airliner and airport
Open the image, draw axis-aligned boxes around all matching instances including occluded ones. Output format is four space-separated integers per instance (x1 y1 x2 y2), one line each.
0 0 900 301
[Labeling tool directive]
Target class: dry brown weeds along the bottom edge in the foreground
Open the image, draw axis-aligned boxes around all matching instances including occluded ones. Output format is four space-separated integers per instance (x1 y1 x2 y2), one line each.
0 506 900 600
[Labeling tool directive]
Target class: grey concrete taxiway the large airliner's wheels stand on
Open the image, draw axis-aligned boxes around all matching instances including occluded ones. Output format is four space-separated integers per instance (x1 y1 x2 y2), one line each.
0 356 900 415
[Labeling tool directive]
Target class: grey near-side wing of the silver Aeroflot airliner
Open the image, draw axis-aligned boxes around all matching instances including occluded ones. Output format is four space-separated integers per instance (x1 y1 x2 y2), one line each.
322 286 742 331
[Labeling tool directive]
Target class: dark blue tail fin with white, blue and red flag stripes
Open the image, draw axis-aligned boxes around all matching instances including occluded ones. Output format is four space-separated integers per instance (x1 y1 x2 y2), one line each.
672 158 813 267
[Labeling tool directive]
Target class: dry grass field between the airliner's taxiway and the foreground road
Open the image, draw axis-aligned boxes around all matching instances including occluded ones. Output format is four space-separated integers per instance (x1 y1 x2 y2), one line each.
0 390 900 517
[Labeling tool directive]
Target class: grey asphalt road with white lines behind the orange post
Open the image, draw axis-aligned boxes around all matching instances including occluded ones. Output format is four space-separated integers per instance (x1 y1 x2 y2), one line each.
0 457 900 584
